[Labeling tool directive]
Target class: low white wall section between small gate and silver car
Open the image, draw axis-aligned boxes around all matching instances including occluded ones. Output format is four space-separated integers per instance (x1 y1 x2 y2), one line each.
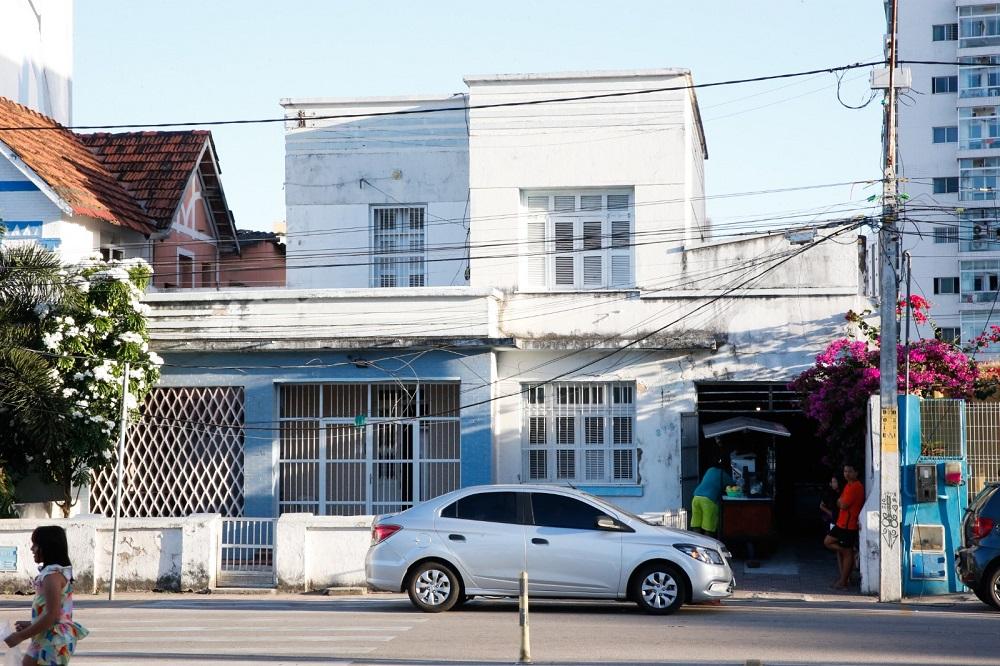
274 513 374 591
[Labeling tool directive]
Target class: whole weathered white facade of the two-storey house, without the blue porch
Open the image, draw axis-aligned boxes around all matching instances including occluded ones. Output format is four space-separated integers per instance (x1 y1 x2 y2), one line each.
256 69 868 511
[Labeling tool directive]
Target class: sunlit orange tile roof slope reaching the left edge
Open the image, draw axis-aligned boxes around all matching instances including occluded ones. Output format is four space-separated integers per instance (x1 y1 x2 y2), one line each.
0 97 154 235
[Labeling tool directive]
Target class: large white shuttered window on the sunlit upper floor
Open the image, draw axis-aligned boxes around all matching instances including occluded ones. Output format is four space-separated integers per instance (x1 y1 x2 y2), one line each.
521 193 634 290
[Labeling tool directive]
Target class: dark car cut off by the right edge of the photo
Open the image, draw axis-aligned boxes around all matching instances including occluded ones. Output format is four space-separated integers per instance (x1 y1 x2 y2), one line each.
955 483 1000 610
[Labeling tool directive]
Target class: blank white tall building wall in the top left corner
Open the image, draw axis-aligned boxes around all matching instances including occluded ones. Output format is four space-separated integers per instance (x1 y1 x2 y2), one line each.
0 0 73 125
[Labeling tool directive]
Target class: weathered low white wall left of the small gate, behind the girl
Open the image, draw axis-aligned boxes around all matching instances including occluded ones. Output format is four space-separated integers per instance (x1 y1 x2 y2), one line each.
0 514 222 593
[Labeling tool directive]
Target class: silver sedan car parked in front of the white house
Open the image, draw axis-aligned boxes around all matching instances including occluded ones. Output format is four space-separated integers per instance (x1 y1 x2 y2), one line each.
365 485 735 614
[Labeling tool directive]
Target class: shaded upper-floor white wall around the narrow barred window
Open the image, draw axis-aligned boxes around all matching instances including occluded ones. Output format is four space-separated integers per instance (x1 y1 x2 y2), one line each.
282 96 469 288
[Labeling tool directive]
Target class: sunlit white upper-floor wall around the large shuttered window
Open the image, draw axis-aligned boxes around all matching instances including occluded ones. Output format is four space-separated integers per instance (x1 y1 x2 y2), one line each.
465 70 704 289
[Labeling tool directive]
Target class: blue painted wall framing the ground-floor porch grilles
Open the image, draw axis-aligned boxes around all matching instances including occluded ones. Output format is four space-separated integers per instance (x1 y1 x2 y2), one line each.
159 349 495 516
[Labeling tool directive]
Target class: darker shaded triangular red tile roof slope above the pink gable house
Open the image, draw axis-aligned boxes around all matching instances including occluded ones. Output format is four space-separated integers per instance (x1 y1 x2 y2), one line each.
78 130 212 231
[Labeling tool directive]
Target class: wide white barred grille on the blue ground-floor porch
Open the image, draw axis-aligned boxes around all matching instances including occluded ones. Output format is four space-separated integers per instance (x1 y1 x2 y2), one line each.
278 383 461 516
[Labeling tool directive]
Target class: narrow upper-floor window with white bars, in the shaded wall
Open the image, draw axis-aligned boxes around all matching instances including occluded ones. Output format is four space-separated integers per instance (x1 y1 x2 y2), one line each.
371 206 427 287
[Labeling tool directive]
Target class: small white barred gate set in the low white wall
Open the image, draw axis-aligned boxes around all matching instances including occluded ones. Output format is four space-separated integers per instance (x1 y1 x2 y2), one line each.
218 518 275 587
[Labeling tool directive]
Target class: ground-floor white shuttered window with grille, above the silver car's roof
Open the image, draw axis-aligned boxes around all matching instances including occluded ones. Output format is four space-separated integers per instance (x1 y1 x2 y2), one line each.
522 382 637 484
